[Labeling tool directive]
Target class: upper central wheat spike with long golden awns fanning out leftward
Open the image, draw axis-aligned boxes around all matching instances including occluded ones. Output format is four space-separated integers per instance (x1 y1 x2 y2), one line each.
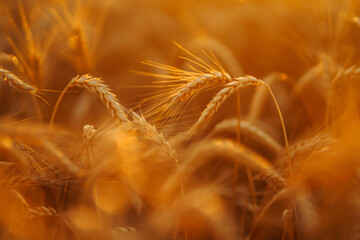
138 43 233 125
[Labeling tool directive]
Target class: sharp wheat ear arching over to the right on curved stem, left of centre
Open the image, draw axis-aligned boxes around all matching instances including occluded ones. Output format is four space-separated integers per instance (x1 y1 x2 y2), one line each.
50 74 129 126
